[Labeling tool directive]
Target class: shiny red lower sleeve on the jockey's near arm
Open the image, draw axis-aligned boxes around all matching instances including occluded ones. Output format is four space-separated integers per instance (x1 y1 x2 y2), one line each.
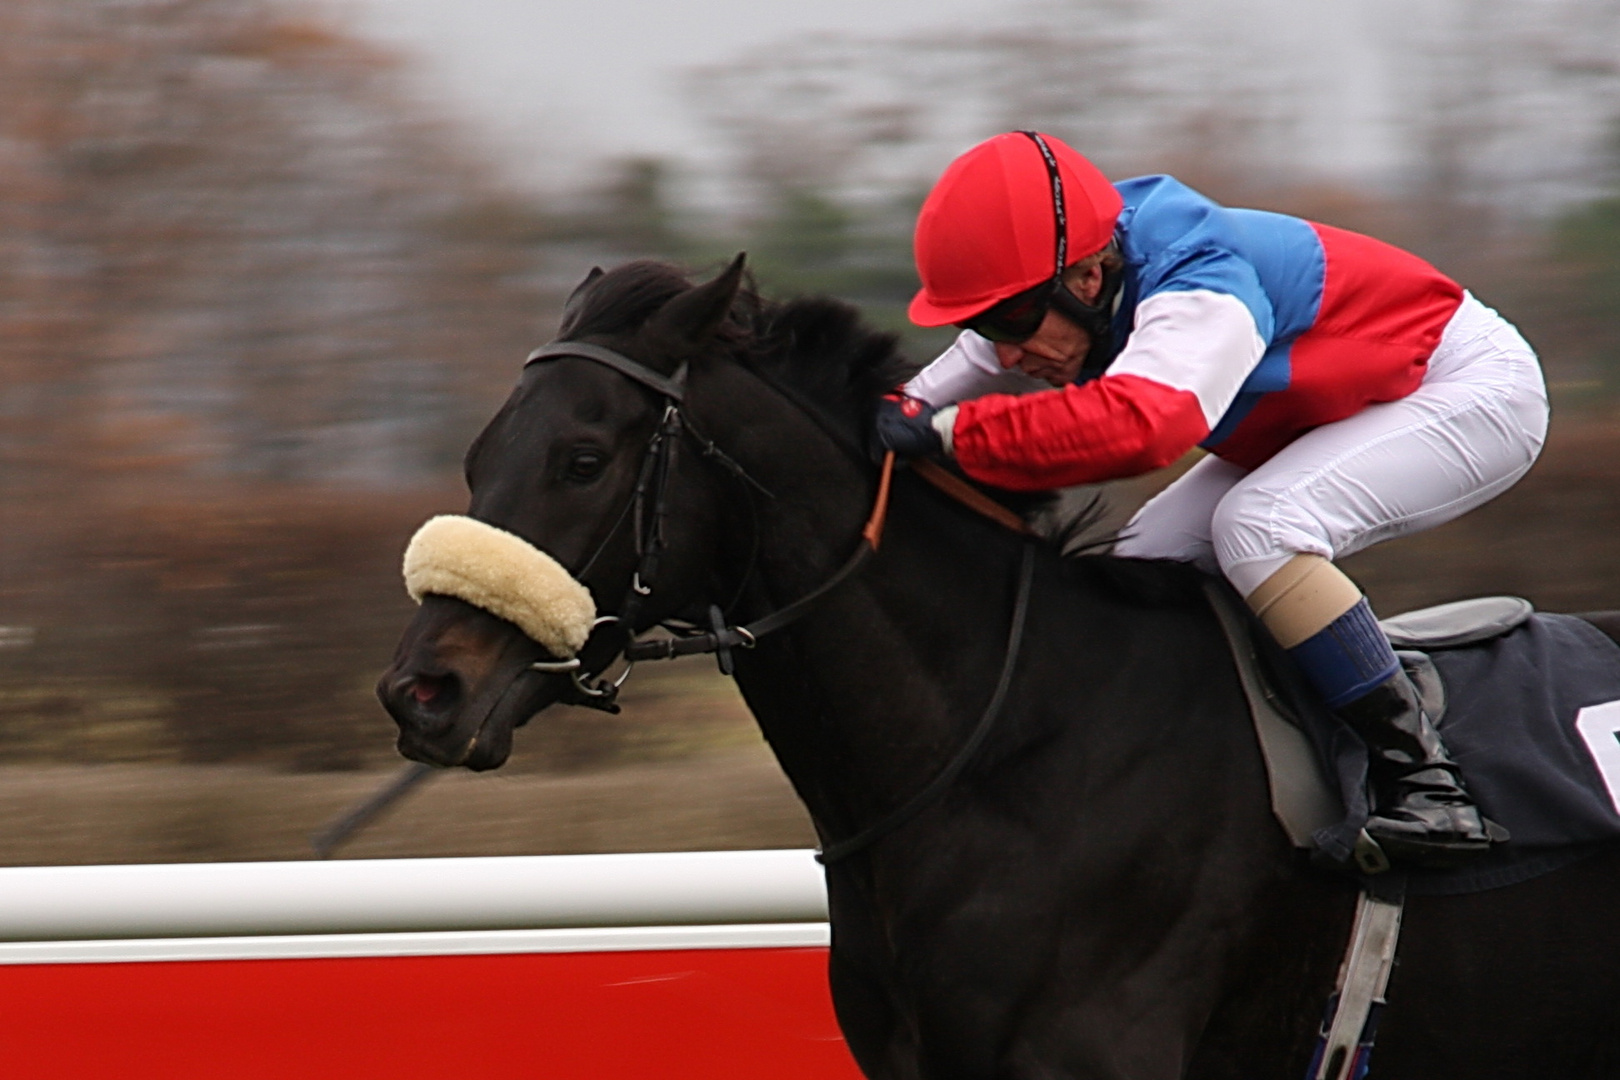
951 374 1210 491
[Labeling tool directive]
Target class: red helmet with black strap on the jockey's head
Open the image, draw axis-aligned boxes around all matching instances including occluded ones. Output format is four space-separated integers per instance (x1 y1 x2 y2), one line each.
909 131 1124 325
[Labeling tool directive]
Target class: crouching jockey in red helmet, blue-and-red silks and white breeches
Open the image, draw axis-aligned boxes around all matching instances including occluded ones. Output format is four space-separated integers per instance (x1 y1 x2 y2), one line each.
876 131 1547 865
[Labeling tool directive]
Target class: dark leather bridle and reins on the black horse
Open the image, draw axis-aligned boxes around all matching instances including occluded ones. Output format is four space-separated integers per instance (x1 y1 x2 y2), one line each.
523 342 1035 865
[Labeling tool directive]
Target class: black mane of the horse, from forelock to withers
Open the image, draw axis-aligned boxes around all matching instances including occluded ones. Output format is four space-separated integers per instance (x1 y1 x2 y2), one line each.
557 259 1199 604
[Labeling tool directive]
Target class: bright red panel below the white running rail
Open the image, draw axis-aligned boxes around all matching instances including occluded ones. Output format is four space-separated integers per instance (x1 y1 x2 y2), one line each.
0 947 860 1080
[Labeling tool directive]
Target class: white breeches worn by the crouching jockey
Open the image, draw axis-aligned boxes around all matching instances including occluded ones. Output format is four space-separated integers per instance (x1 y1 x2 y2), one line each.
1115 295 1547 596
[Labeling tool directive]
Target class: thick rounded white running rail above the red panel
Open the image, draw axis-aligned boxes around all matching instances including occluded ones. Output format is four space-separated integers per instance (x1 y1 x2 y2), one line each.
0 850 826 942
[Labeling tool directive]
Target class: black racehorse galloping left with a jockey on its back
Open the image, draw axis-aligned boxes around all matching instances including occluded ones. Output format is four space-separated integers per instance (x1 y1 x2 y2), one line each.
379 259 1620 1080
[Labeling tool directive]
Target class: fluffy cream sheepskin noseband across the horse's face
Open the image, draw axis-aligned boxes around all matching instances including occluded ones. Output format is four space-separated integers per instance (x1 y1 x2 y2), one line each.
405 513 596 659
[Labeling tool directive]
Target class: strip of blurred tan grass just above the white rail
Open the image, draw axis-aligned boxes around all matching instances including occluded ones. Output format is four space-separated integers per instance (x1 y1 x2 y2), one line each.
0 743 815 866
